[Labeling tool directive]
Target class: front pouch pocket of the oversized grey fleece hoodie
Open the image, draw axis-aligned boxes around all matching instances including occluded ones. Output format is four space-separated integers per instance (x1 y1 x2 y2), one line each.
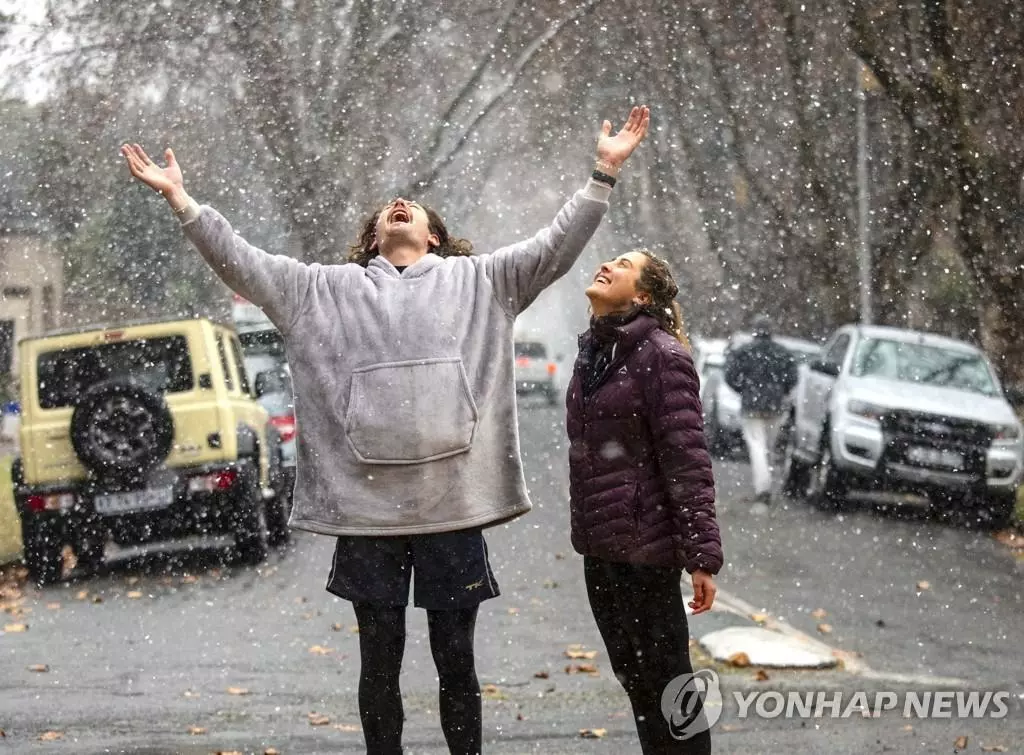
345 356 478 464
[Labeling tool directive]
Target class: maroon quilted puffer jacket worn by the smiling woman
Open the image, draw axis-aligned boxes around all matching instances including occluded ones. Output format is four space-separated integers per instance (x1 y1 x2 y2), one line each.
566 314 722 574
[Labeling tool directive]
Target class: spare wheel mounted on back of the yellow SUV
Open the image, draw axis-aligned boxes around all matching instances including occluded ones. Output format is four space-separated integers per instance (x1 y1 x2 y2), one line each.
71 379 174 476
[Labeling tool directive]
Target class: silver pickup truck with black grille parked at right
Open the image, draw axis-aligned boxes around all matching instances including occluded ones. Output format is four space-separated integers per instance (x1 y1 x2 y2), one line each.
779 325 1024 526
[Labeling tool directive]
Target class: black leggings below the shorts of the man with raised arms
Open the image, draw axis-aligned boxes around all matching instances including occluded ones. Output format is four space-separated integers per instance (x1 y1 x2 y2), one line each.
354 603 481 755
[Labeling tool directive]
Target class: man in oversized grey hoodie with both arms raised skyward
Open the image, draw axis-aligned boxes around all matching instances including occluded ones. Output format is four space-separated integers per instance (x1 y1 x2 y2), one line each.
121 108 650 755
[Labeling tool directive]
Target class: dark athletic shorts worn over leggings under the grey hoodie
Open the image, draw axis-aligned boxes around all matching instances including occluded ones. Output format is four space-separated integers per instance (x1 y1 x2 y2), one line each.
327 529 500 611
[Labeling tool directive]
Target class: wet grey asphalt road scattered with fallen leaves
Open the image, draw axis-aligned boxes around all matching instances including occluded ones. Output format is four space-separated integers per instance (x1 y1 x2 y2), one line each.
0 402 1024 755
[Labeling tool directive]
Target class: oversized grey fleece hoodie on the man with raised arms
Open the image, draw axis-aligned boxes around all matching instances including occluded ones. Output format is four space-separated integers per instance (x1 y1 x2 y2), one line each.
183 180 610 536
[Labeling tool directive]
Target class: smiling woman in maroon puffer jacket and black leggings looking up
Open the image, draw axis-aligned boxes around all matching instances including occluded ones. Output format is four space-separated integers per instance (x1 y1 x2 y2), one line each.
566 250 722 755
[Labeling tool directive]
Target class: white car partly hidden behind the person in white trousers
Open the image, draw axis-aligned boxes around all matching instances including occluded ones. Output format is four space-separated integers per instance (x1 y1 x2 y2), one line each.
698 333 821 454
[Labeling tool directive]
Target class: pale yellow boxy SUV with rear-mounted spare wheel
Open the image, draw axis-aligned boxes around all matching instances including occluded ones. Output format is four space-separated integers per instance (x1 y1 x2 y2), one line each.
12 319 291 584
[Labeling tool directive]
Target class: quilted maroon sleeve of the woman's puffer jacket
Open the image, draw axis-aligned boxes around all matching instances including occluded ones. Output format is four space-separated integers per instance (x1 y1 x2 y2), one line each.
644 340 722 574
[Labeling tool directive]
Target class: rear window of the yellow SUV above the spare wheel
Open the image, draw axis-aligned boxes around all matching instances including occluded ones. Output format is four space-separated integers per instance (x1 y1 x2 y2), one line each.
37 336 193 409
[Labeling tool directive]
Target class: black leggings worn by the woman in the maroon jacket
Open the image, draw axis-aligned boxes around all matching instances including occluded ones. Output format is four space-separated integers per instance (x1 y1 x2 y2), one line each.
584 556 711 755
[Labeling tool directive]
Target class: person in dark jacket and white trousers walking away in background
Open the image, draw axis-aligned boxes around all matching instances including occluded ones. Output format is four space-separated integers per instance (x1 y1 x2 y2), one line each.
725 314 798 510
